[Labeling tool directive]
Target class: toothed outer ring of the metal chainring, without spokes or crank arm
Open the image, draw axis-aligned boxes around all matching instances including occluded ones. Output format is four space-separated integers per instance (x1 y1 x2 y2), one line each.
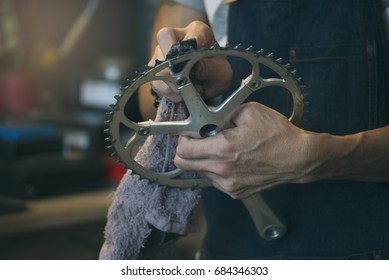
104 44 306 188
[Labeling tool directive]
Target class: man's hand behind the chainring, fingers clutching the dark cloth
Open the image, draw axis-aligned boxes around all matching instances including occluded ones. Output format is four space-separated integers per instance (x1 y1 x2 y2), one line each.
149 21 232 102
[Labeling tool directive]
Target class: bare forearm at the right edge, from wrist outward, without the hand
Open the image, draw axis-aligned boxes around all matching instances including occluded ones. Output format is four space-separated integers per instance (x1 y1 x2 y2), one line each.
307 126 389 182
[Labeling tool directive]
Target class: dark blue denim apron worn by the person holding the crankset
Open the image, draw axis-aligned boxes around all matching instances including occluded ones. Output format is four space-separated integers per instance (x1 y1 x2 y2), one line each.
203 0 389 259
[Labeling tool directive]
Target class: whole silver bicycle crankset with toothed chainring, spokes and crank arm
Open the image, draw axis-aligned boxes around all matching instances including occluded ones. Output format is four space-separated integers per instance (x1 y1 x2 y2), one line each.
106 42 304 240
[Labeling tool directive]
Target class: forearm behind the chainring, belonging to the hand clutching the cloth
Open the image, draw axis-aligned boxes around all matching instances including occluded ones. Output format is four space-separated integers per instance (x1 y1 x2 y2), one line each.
139 1 207 120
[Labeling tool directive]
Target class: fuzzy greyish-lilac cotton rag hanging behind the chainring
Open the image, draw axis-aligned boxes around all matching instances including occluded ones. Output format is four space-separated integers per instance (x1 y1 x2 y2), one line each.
99 98 200 260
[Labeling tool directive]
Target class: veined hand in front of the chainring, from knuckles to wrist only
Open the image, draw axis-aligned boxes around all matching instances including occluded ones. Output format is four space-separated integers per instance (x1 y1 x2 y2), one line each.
175 103 316 198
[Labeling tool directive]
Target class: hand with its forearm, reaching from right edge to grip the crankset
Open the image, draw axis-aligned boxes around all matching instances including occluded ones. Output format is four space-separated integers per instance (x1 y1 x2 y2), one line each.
175 98 389 199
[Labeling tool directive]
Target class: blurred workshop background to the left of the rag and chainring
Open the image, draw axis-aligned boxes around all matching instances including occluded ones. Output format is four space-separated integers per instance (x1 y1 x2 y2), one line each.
0 0 203 260
